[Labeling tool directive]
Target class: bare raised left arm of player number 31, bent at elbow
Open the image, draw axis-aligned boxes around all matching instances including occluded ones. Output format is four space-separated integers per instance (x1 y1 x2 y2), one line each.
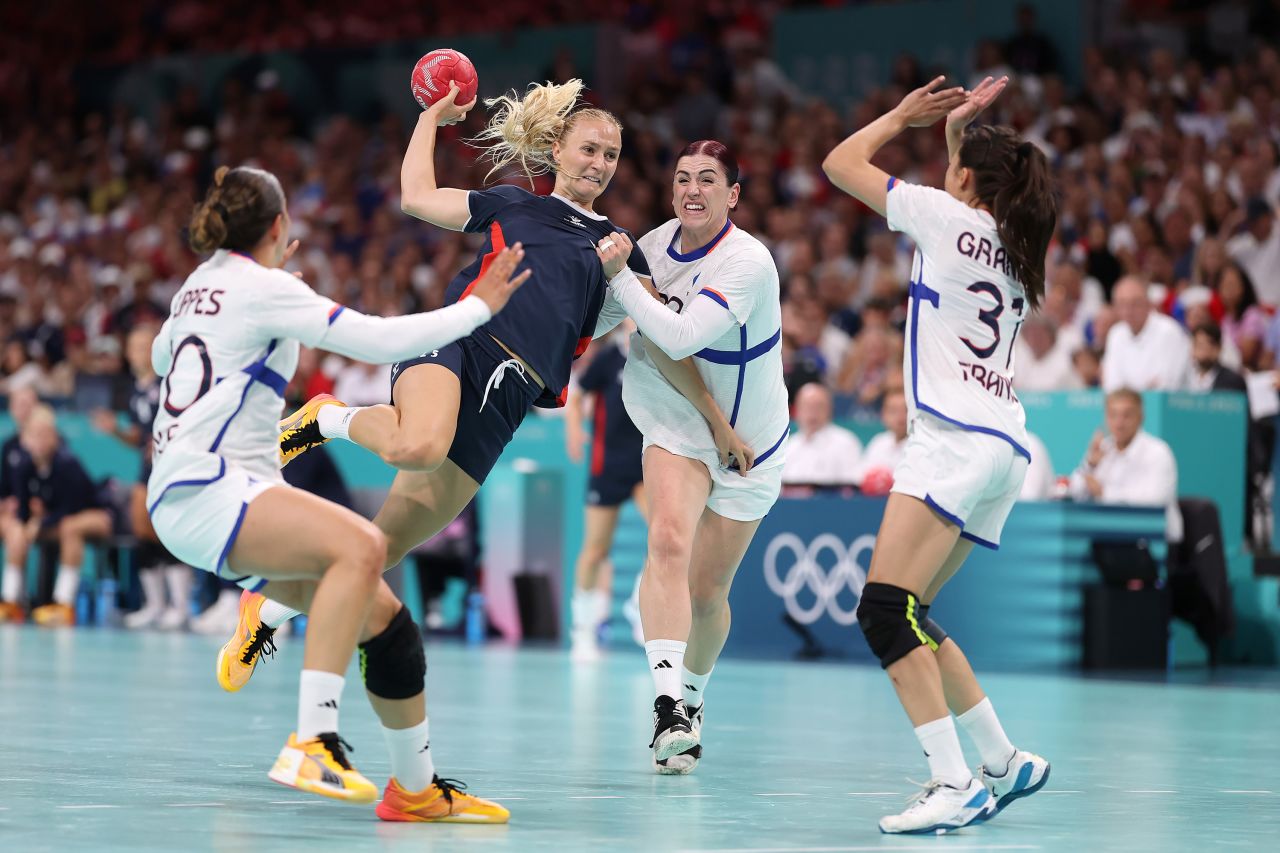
822 77 968 216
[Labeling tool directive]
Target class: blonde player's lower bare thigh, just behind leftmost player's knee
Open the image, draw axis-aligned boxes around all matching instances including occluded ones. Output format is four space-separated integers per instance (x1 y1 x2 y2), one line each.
374 459 480 566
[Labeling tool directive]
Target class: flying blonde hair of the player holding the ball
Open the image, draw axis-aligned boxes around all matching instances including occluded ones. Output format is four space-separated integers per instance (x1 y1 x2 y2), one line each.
467 78 622 181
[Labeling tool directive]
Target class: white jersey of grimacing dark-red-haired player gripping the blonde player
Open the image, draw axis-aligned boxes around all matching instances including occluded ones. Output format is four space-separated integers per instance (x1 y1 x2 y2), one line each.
622 219 790 470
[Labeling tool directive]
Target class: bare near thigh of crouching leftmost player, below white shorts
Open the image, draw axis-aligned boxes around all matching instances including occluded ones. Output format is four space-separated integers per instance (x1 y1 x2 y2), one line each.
227 485 387 580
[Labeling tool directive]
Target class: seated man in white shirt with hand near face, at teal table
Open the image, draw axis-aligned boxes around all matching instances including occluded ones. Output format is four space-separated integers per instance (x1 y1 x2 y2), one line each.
1071 388 1183 542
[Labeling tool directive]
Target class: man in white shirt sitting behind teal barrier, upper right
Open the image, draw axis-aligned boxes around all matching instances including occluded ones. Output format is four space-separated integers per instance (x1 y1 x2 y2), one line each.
1102 275 1192 392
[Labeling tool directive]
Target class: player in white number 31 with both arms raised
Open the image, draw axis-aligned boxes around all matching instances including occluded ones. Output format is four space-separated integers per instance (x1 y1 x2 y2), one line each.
823 77 1057 834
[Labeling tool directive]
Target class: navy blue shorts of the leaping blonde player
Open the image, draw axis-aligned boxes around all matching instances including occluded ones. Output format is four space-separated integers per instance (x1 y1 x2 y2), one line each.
392 332 543 483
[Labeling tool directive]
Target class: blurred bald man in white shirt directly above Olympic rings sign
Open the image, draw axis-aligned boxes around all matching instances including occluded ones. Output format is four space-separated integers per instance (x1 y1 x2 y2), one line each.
782 382 863 492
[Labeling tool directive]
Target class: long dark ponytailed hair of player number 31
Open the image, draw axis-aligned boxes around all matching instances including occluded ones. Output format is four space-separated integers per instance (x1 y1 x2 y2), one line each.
960 127 1057 309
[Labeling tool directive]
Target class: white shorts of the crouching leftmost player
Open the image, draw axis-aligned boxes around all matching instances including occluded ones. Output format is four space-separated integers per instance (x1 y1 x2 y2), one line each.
147 453 285 592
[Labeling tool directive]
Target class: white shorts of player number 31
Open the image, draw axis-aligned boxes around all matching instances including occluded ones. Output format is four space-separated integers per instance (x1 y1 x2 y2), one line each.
893 412 1029 549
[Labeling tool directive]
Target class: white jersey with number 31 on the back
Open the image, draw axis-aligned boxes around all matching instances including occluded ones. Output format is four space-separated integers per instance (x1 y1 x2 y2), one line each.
886 178 1030 459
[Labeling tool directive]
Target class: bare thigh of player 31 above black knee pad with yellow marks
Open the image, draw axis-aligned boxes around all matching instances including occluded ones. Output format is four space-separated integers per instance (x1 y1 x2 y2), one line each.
867 492 960 597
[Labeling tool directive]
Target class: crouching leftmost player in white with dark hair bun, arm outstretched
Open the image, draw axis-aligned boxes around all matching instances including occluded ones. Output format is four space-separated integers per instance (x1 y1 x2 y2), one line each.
147 167 529 822
